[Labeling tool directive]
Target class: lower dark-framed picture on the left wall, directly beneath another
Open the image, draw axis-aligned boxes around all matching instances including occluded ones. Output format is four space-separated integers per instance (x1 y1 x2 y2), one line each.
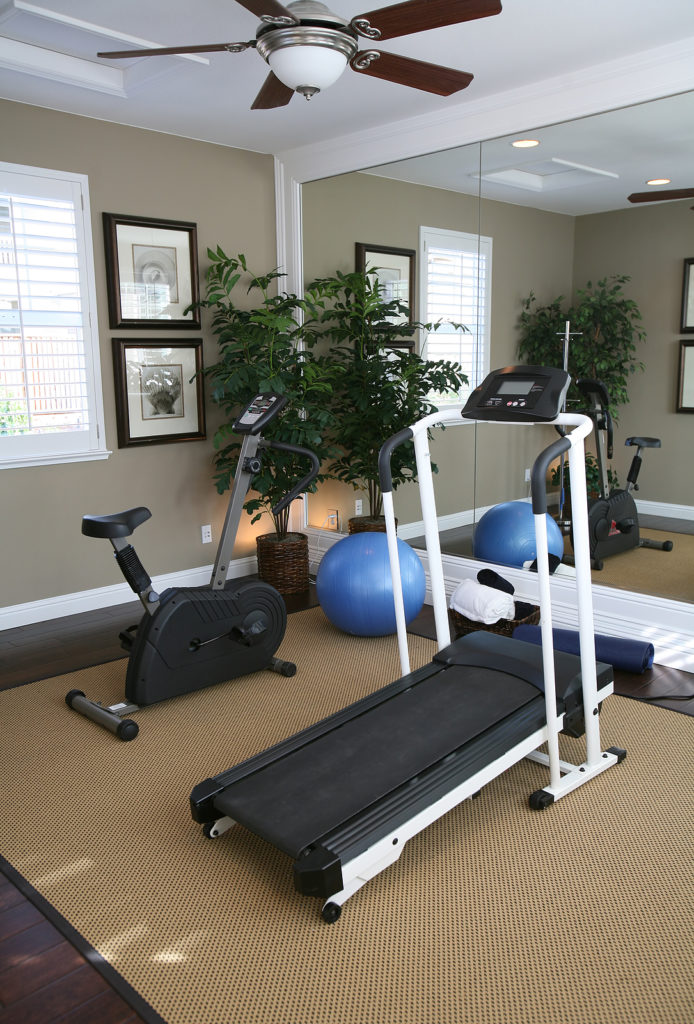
113 338 206 447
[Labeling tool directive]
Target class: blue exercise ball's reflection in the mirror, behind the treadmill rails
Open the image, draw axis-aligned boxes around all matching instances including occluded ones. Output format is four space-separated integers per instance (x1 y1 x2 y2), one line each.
472 502 564 567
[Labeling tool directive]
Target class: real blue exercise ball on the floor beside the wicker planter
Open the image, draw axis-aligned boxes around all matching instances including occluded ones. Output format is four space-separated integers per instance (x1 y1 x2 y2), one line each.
315 532 426 637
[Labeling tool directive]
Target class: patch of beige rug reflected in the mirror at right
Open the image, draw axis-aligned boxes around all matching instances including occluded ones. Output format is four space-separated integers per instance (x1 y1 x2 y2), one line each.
592 529 694 602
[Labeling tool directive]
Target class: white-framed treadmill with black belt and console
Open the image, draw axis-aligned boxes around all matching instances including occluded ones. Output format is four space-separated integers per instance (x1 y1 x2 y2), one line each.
190 367 626 923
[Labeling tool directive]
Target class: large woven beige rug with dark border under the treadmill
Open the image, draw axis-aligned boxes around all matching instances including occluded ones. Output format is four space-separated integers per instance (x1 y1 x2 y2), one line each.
0 609 694 1024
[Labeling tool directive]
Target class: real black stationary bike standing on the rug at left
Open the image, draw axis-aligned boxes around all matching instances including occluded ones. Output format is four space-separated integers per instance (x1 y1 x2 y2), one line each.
66 392 319 740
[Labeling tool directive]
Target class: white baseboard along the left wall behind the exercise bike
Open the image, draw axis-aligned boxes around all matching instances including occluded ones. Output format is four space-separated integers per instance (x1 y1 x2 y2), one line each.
0 556 258 630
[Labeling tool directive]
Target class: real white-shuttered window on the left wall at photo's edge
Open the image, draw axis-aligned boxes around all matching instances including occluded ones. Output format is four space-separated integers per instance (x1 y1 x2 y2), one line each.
0 163 109 469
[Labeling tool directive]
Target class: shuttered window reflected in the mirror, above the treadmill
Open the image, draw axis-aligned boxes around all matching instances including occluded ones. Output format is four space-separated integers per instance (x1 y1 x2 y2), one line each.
420 227 491 406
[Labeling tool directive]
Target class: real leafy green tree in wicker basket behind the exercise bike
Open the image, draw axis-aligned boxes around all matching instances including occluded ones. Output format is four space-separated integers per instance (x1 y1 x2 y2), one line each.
193 246 335 594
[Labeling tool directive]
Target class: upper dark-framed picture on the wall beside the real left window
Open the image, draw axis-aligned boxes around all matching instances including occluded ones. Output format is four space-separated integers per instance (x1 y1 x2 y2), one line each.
103 213 200 330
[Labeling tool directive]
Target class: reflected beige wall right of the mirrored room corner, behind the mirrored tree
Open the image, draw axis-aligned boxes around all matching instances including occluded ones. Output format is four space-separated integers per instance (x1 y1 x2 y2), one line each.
574 201 694 506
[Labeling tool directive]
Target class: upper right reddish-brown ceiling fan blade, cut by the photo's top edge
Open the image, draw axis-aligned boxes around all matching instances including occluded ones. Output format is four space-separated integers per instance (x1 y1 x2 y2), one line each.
351 0 502 39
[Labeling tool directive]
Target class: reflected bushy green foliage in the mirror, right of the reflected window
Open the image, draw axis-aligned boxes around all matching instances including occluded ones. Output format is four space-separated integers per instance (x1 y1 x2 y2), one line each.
518 274 646 421
